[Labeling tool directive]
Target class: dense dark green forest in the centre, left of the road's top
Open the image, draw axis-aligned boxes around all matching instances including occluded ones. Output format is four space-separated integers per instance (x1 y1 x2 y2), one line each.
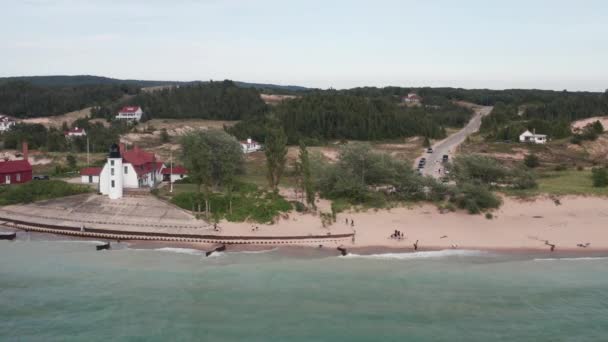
231 92 472 143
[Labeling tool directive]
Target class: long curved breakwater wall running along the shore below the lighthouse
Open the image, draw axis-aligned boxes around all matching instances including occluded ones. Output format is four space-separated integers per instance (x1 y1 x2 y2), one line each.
0 217 353 245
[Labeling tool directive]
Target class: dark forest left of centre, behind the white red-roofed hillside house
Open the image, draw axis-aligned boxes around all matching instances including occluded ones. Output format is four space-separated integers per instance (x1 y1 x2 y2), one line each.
93 81 266 120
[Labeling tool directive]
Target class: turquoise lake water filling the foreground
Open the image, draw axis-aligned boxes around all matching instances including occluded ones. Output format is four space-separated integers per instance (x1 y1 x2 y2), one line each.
0 235 608 342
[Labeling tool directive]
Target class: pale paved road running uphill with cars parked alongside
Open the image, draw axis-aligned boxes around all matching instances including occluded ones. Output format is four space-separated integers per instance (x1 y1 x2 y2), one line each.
414 106 493 178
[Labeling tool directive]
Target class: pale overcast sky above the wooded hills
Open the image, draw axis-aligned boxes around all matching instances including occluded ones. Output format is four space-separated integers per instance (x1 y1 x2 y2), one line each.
0 0 608 91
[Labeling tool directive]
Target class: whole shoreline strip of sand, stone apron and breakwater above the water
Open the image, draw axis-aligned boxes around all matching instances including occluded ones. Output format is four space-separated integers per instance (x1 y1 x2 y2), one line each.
0 196 608 255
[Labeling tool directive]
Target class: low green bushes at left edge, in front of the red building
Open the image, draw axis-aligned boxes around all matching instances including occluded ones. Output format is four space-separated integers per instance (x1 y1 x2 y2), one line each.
0 180 92 205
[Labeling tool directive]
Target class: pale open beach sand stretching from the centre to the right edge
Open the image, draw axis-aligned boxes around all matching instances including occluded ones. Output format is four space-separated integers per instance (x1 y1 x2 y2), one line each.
216 196 608 251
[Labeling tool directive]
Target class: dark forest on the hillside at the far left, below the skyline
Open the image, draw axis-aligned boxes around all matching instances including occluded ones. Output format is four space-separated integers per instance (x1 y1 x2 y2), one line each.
0 81 138 118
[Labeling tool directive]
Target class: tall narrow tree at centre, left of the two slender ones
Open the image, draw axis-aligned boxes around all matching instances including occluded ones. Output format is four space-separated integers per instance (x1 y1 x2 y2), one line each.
264 122 287 192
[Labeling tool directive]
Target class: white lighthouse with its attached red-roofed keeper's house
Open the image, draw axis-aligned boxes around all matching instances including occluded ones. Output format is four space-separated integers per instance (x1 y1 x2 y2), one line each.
80 144 165 199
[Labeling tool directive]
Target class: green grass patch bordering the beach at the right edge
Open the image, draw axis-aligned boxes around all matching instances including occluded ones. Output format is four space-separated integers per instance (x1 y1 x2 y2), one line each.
507 170 608 196
